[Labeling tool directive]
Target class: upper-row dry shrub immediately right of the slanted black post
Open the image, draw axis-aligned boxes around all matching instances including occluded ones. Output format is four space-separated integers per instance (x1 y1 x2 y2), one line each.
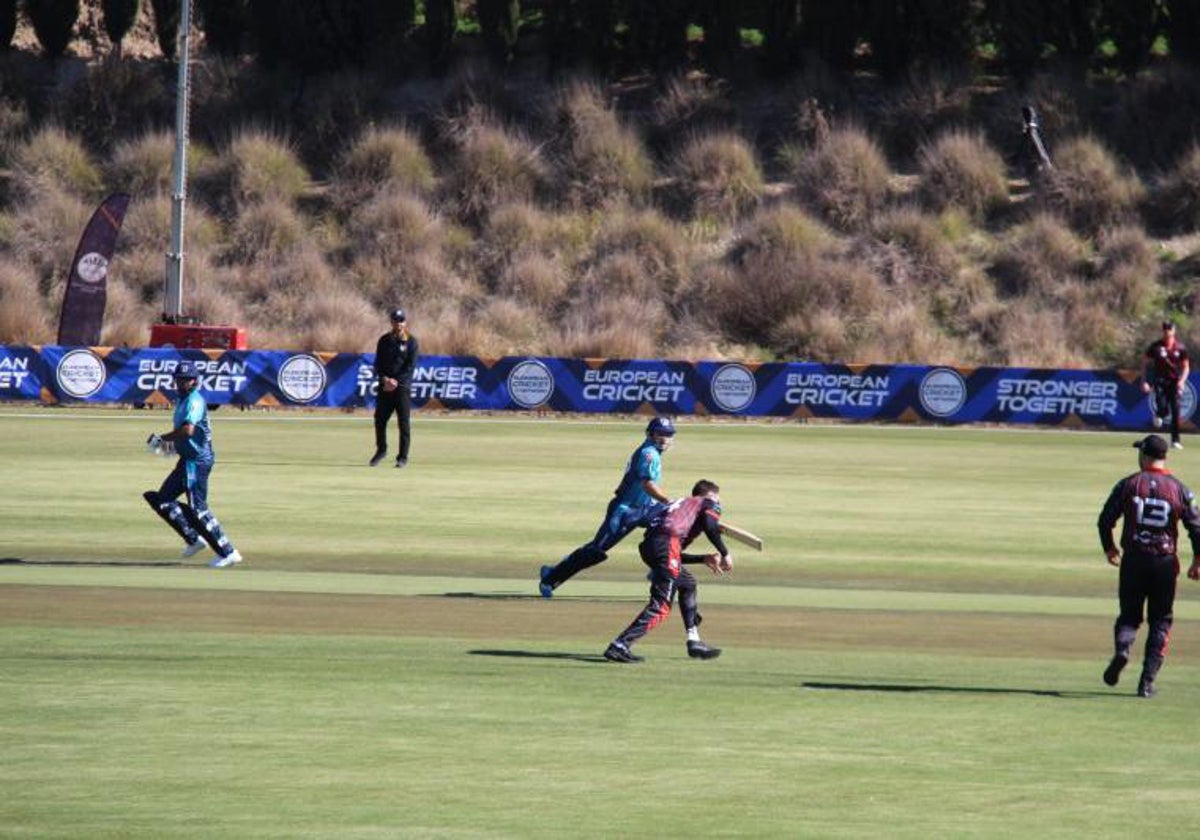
1039 137 1145 234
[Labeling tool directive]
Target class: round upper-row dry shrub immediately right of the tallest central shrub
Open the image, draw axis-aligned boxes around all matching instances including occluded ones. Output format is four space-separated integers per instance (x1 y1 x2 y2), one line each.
672 132 766 220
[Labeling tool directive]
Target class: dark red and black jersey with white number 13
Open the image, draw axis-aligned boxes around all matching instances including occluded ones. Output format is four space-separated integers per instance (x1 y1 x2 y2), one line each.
1097 468 1200 557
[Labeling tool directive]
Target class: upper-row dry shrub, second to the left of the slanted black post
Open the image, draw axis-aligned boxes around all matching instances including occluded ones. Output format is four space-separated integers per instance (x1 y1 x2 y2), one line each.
784 128 892 230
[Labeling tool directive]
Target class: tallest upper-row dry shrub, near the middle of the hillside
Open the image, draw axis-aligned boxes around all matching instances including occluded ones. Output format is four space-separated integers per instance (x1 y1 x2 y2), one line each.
556 82 654 208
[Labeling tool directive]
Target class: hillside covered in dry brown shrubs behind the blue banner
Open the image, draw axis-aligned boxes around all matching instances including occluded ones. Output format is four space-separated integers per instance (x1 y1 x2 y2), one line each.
0 9 1200 366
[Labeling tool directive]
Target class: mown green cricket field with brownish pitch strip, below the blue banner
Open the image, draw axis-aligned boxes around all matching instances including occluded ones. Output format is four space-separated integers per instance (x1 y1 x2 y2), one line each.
0 408 1200 838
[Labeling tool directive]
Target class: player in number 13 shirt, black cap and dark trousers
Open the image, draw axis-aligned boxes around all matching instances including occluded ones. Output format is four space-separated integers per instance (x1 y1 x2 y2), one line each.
1097 434 1200 697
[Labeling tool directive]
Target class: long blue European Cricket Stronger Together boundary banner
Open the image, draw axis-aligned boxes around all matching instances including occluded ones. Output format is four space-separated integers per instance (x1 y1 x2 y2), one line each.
0 346 1196 431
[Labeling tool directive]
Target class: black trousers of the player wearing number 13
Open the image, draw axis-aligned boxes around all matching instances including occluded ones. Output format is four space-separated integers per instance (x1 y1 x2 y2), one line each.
1112 552 1180 679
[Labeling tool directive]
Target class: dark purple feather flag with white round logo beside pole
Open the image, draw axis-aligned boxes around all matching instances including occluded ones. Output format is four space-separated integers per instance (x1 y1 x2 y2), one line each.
58 192 130 347
